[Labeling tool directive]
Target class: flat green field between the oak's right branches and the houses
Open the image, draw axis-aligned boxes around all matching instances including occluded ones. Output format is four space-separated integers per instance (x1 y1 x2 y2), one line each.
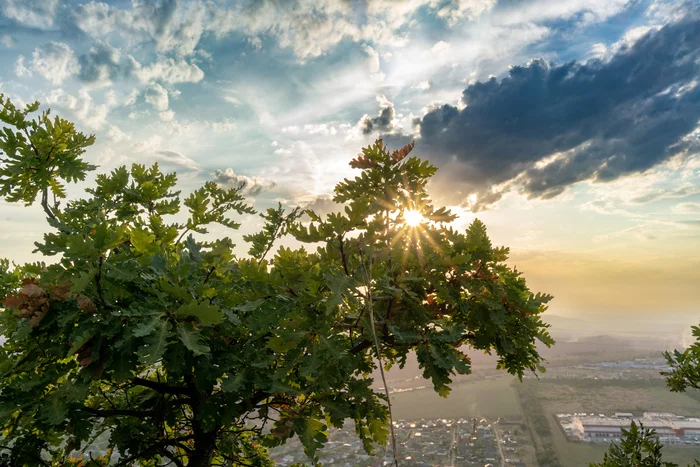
391 376 522 420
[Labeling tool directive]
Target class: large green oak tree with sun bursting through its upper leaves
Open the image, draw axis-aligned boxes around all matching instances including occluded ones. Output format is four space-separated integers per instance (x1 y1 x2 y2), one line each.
0 96 553 467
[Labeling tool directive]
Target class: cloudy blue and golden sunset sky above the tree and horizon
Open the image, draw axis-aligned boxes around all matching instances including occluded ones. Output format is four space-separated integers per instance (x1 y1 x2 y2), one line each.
0 0 700 323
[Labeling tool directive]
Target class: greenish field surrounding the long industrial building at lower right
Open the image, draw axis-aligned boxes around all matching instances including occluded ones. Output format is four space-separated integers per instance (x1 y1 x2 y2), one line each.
514 380 700 467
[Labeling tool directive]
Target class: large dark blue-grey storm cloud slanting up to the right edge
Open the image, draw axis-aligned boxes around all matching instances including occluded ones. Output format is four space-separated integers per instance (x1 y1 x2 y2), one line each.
419 15 700 203
